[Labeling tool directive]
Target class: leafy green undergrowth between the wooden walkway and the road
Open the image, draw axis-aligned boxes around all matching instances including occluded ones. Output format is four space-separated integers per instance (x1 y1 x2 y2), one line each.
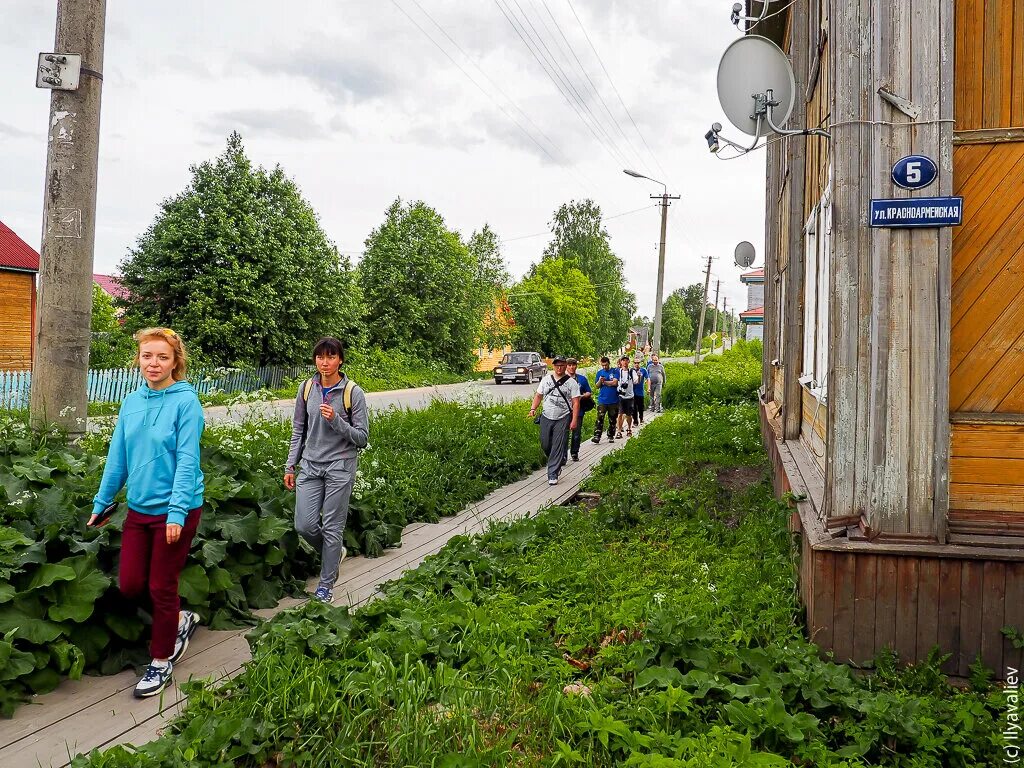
0 402 543 716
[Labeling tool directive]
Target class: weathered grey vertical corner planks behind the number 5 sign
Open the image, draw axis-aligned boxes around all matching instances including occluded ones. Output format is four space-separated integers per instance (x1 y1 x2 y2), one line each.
826 0 953 540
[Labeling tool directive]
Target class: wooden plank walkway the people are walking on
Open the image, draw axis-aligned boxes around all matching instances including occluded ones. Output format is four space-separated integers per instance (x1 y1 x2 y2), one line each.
0 415 654 768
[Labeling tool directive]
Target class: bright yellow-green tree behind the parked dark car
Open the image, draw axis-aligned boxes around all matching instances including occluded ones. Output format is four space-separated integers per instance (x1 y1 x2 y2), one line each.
510 259 597 356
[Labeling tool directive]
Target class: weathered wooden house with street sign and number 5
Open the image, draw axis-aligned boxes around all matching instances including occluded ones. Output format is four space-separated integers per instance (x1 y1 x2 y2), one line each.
744 0 1024 677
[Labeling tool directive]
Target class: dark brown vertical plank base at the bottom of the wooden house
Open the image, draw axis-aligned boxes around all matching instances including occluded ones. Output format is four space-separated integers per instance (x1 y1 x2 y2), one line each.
801 548 1024 678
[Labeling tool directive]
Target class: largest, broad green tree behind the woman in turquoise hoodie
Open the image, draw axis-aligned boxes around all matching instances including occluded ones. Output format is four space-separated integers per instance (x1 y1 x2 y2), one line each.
121 133 360 366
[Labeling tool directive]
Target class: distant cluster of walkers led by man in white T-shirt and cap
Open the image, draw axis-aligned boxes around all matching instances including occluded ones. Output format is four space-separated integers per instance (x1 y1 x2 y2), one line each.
529 352 666 485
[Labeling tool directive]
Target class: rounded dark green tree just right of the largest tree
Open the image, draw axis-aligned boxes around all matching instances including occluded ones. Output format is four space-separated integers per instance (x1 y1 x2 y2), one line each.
359 200 481 371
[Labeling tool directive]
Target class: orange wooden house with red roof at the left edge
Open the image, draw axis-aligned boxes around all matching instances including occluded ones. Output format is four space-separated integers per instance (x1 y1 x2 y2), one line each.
0 221 39 371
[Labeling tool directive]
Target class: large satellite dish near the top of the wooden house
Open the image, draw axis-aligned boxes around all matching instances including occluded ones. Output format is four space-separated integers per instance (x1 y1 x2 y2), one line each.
718 35 797 137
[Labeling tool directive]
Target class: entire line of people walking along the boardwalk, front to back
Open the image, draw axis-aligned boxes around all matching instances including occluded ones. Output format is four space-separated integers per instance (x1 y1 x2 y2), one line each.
87 328 666 698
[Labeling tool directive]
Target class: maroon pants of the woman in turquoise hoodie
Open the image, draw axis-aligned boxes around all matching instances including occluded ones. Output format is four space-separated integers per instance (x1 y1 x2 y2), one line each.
119 508 202 658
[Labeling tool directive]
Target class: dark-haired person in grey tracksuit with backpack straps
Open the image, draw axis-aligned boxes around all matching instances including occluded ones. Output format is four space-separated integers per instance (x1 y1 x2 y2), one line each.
285 337 370 603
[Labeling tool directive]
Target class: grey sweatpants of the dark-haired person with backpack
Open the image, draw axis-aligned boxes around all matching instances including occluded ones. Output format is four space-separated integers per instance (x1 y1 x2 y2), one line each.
295 458 358 590
